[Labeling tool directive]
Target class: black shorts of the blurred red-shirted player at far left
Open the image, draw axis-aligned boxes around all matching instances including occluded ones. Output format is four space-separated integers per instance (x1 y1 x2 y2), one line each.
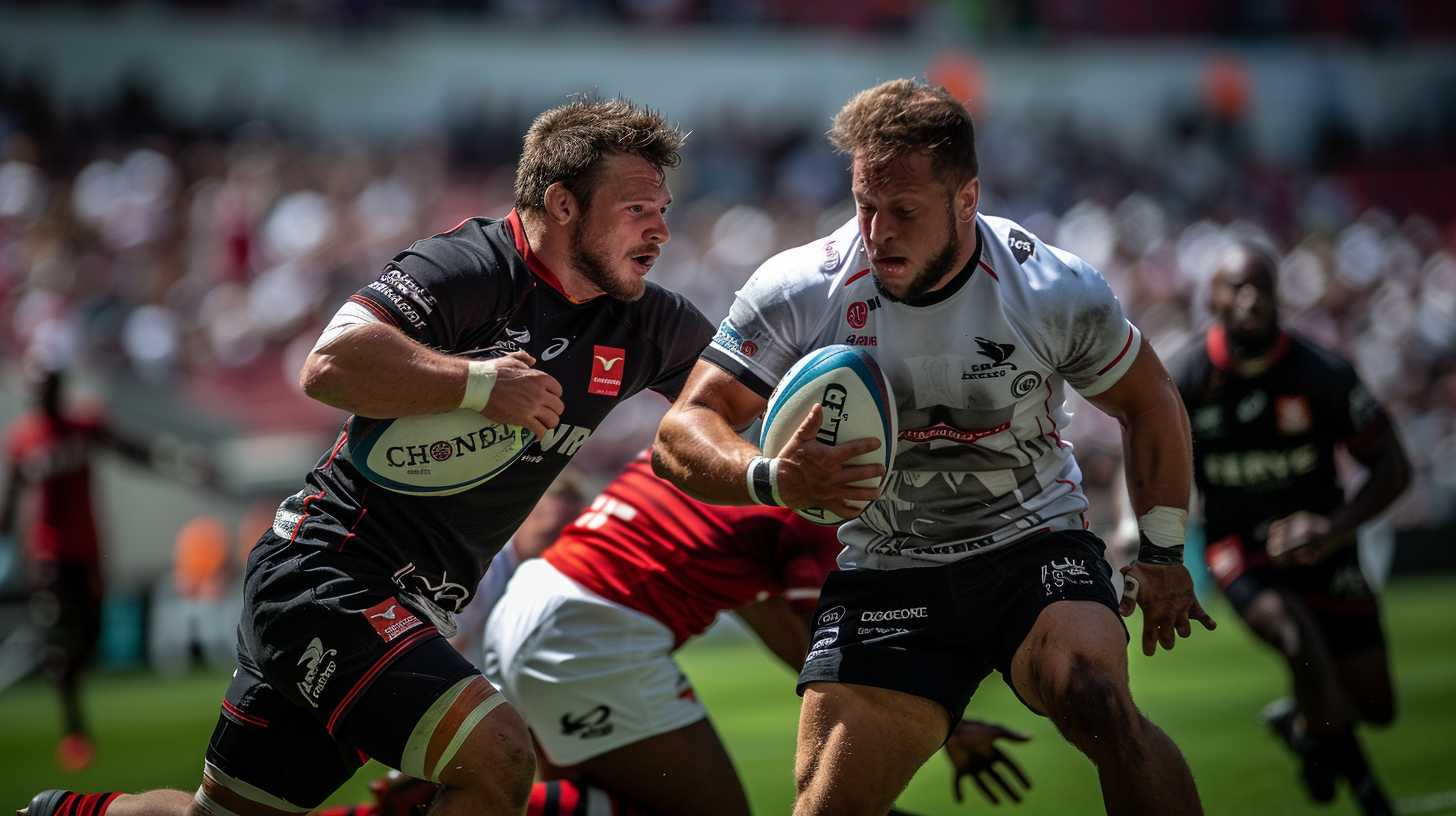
31 560 103 673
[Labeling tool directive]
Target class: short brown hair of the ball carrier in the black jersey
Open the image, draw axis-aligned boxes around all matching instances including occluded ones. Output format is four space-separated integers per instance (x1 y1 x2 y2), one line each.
515 98 686 210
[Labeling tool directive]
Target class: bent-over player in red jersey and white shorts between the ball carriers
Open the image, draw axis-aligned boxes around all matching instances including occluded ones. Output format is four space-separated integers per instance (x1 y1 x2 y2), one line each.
323 453 1029 816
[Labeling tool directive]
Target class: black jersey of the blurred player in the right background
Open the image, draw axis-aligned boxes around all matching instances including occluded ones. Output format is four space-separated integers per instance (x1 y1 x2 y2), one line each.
1169 326 1389 551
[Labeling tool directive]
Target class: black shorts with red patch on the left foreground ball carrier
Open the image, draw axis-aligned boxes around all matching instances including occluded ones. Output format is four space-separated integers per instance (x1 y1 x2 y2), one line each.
207 533 479 810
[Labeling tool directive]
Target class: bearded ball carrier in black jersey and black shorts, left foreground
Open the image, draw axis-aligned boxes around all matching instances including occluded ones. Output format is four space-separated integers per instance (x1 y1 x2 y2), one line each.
15 99 712 816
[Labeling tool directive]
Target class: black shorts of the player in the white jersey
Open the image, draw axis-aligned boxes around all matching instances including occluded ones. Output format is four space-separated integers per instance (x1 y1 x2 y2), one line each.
798 530 1125 723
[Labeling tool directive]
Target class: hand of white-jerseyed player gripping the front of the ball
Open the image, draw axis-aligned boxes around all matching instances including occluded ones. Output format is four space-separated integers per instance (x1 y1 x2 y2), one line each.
779 405 885 519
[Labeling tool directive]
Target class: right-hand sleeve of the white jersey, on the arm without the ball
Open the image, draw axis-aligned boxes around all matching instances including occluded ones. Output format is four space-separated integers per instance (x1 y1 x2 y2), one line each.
1028 246 1143 398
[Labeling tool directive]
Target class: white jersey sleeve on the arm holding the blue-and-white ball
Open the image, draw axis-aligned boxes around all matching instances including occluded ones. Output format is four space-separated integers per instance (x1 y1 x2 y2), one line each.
703 248 817 399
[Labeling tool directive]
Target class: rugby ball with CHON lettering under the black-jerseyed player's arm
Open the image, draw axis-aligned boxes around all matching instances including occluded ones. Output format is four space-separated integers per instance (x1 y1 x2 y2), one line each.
345 408 534 495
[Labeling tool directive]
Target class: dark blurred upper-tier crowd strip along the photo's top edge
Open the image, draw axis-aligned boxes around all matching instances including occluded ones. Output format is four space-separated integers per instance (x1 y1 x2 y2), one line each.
5 0 1456 39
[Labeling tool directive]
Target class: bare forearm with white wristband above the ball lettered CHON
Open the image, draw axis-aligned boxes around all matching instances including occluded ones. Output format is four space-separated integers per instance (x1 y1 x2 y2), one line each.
298 323 469 418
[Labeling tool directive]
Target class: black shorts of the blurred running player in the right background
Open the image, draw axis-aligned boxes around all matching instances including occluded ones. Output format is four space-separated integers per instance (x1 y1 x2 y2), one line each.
1210 546 1385 657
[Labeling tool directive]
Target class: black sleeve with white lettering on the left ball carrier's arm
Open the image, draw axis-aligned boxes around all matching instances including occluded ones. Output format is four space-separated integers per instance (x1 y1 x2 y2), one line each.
349 236 511 351
